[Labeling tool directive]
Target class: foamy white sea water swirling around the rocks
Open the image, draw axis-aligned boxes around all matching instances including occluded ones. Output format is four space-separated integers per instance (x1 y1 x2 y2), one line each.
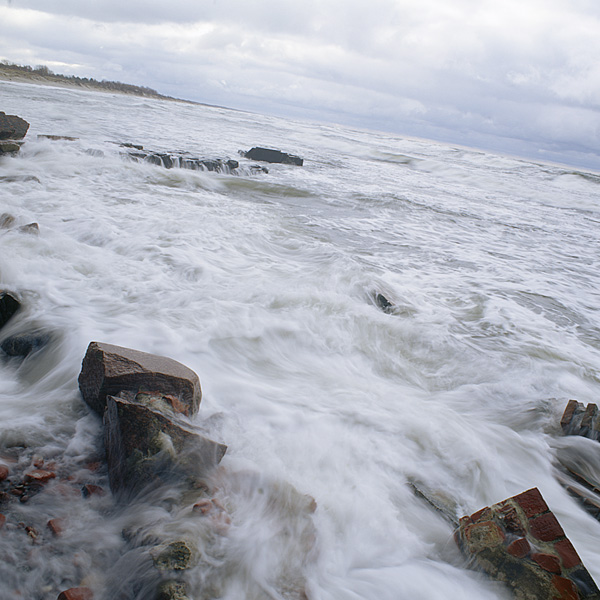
0 82 600 600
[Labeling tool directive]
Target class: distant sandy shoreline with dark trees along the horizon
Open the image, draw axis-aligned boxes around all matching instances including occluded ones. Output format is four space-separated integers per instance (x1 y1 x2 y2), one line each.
0 64 204 106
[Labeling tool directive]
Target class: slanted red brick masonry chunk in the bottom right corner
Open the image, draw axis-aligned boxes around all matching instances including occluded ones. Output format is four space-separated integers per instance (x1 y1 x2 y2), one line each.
455 488 600 600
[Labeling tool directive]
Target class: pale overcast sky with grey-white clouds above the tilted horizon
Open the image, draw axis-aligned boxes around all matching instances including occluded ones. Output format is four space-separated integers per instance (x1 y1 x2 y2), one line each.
0 0 600 171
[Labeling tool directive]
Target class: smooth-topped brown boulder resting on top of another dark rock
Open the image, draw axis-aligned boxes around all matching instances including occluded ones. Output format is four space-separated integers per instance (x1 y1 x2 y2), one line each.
79 342 202 416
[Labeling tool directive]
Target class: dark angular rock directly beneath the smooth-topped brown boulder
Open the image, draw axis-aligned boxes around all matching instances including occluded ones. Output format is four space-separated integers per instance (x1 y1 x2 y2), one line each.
104 396 227 492
